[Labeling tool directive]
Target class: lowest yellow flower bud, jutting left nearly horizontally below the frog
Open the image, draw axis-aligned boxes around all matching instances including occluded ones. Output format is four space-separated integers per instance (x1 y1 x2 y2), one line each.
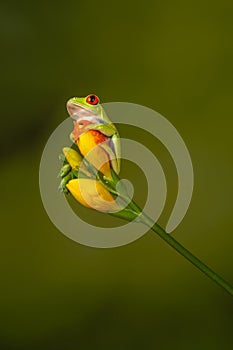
66 178 121 212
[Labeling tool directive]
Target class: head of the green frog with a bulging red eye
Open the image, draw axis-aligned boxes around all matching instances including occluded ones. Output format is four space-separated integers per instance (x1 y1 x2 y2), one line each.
67 94 105 119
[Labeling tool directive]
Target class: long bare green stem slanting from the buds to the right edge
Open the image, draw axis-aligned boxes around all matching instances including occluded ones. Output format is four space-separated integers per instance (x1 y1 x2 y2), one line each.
141 213 233 296
